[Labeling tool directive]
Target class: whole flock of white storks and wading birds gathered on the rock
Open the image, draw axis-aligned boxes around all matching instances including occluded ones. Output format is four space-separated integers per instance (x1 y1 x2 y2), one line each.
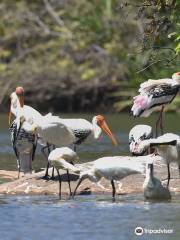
9 72 180 199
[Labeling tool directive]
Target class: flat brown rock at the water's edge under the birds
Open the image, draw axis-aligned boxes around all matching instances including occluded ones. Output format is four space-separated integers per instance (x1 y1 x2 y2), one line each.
0 165 180 195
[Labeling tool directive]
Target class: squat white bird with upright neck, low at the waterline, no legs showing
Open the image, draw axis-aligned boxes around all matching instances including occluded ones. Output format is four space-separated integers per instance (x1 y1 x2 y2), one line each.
143 164 171 200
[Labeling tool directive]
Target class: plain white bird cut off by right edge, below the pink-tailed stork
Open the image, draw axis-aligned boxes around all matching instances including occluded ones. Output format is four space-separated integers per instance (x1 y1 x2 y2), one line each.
136 133 180 186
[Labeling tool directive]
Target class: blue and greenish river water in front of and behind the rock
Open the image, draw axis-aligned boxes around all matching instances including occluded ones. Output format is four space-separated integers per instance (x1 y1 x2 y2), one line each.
0 114 180 240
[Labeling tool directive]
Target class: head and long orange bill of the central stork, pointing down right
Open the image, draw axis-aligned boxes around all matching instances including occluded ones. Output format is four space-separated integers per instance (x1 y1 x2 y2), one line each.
92 115 118 145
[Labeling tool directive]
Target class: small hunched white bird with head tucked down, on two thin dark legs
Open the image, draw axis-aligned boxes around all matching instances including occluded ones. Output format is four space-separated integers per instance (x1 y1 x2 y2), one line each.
48 147 80 198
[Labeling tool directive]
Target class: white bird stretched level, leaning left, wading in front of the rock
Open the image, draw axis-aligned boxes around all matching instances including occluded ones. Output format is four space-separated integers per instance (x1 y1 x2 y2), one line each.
73 155 157 199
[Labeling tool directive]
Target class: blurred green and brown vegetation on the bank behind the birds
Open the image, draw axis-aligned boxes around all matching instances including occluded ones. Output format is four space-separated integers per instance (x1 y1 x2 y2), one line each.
0 0 180 112
